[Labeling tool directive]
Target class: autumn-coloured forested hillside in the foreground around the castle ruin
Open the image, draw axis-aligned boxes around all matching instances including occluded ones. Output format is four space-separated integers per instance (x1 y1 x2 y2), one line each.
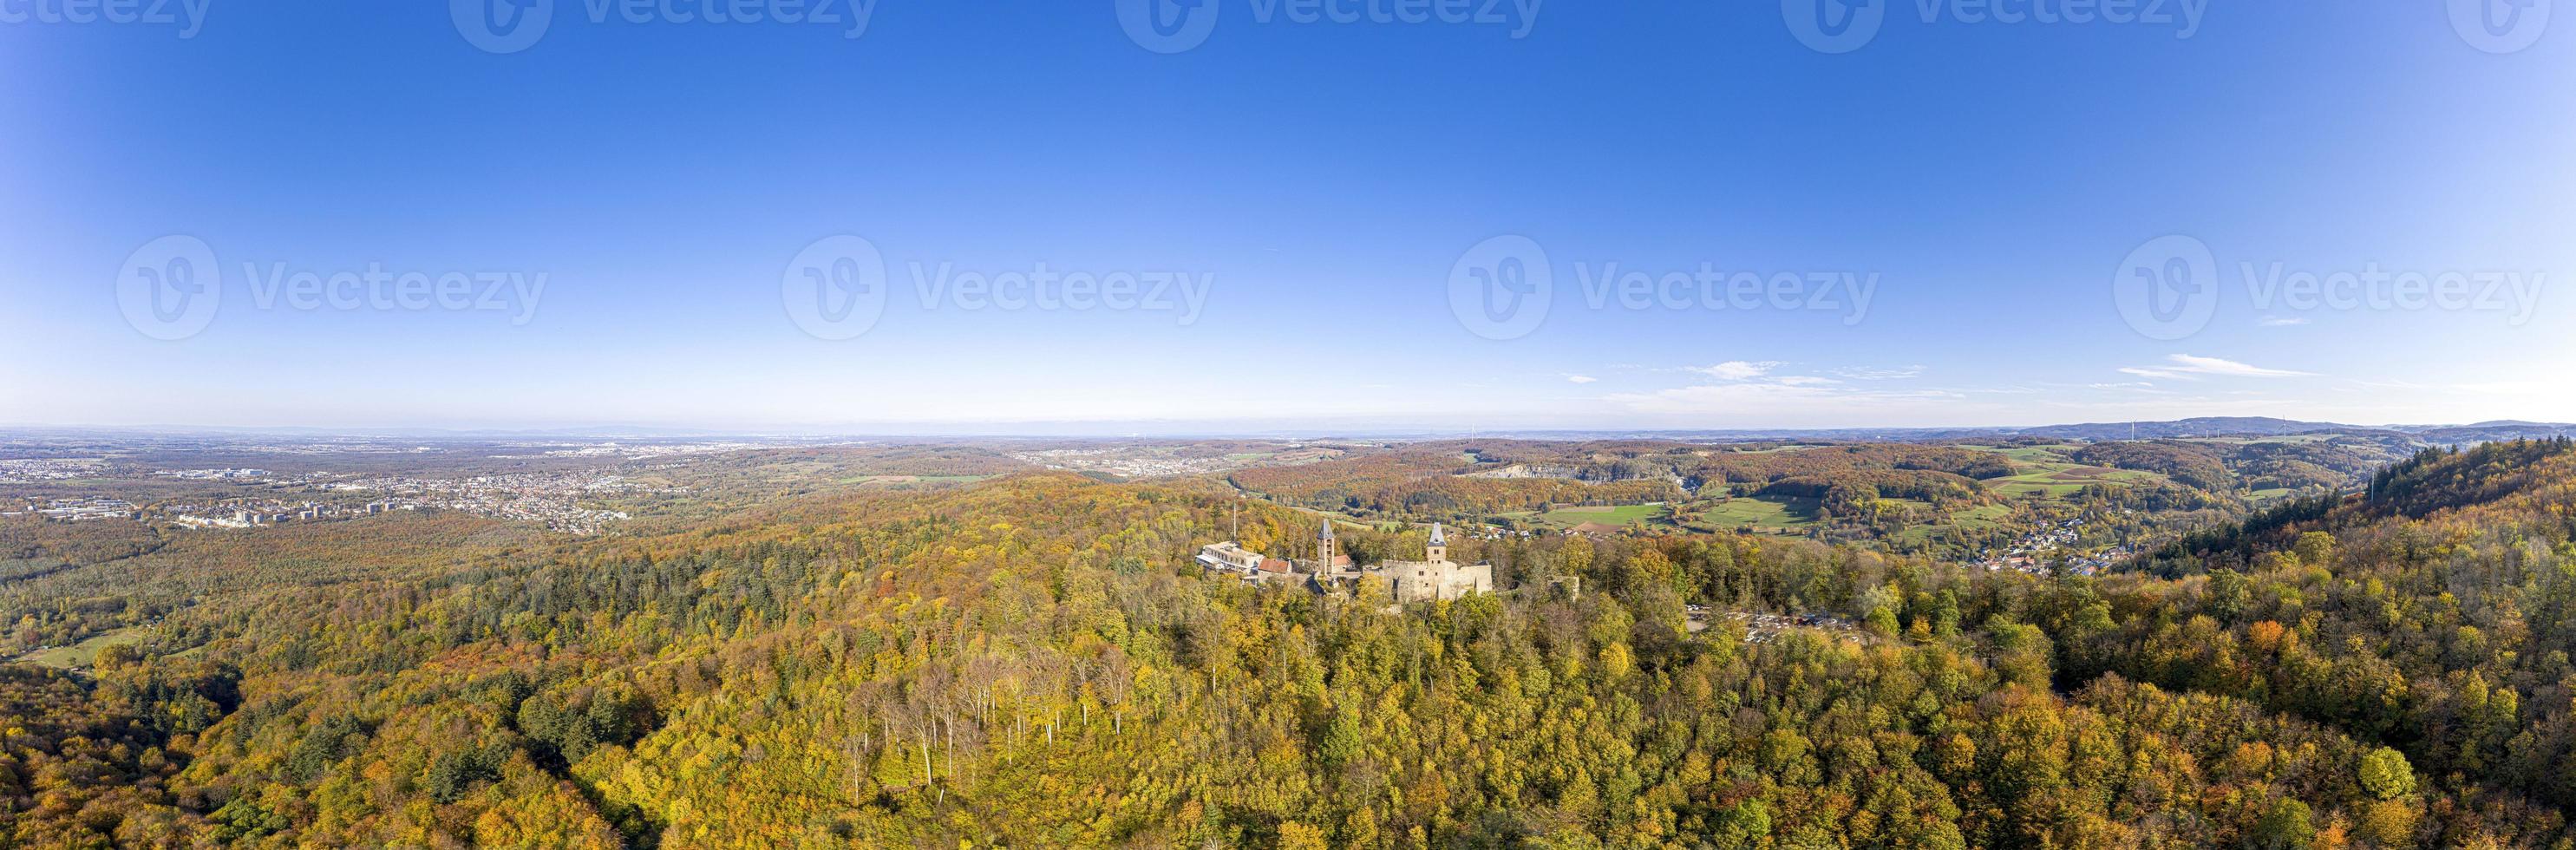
0 441 2576 847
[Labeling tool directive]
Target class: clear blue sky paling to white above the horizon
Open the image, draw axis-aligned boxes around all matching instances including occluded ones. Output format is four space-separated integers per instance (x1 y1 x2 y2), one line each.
0 0 2576 430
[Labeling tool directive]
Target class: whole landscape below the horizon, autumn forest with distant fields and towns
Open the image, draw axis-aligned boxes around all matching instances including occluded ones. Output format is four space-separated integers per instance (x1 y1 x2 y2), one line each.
0 422 2576 847
